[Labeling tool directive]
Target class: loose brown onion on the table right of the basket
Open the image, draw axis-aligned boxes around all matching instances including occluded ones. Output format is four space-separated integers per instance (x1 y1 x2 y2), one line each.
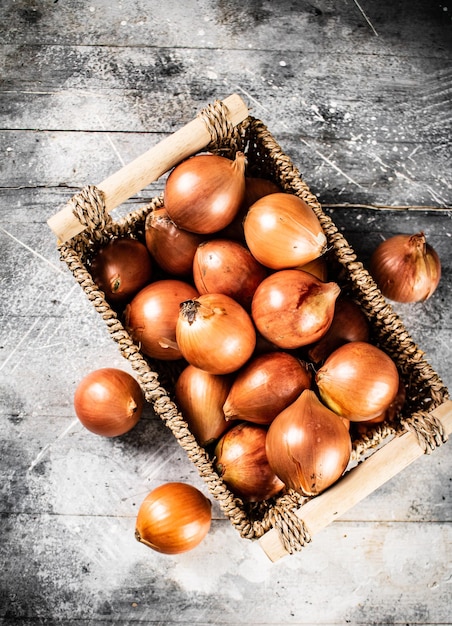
370 232 441 302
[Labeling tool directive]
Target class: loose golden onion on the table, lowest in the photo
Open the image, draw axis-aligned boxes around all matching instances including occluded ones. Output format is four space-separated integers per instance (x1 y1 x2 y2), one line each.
135 482 212 554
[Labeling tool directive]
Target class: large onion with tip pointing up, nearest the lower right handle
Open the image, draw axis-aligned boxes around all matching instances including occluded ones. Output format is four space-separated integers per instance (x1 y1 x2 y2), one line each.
266 389 352 496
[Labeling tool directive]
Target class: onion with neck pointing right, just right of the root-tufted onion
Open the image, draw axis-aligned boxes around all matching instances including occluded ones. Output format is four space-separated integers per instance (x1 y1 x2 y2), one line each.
251 270 340 349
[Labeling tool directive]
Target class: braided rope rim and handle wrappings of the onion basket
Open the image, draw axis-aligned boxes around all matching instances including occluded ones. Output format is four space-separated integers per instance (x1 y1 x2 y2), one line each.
60 113 447 552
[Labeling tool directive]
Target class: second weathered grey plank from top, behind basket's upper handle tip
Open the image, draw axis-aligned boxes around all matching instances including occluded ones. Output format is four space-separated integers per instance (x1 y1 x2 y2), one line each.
2 44 452 139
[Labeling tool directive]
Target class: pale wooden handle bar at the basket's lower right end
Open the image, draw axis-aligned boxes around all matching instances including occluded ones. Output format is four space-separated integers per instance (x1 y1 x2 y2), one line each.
258 400 452 561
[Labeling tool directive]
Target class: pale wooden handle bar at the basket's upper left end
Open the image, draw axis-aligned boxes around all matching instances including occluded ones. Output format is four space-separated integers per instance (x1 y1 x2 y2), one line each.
47 94 248 243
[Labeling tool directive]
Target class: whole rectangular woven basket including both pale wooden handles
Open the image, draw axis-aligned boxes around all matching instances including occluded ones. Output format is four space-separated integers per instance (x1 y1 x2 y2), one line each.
48 94 452 560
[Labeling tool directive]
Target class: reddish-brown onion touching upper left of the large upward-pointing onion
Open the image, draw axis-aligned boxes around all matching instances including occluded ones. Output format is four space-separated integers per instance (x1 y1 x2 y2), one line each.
223 352 312 425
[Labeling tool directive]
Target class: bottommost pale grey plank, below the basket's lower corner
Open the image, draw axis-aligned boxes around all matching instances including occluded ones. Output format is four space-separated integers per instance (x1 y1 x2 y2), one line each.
0 514 452 626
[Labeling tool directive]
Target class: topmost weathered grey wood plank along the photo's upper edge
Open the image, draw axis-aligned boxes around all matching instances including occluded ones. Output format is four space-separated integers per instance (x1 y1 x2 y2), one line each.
0 0 451 58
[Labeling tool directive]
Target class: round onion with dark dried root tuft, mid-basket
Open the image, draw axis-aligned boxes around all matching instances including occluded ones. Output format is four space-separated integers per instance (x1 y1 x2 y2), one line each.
176 293 256 374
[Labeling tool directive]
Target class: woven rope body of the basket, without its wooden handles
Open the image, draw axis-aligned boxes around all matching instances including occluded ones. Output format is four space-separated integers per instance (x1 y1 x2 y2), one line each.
49 95 450 553
